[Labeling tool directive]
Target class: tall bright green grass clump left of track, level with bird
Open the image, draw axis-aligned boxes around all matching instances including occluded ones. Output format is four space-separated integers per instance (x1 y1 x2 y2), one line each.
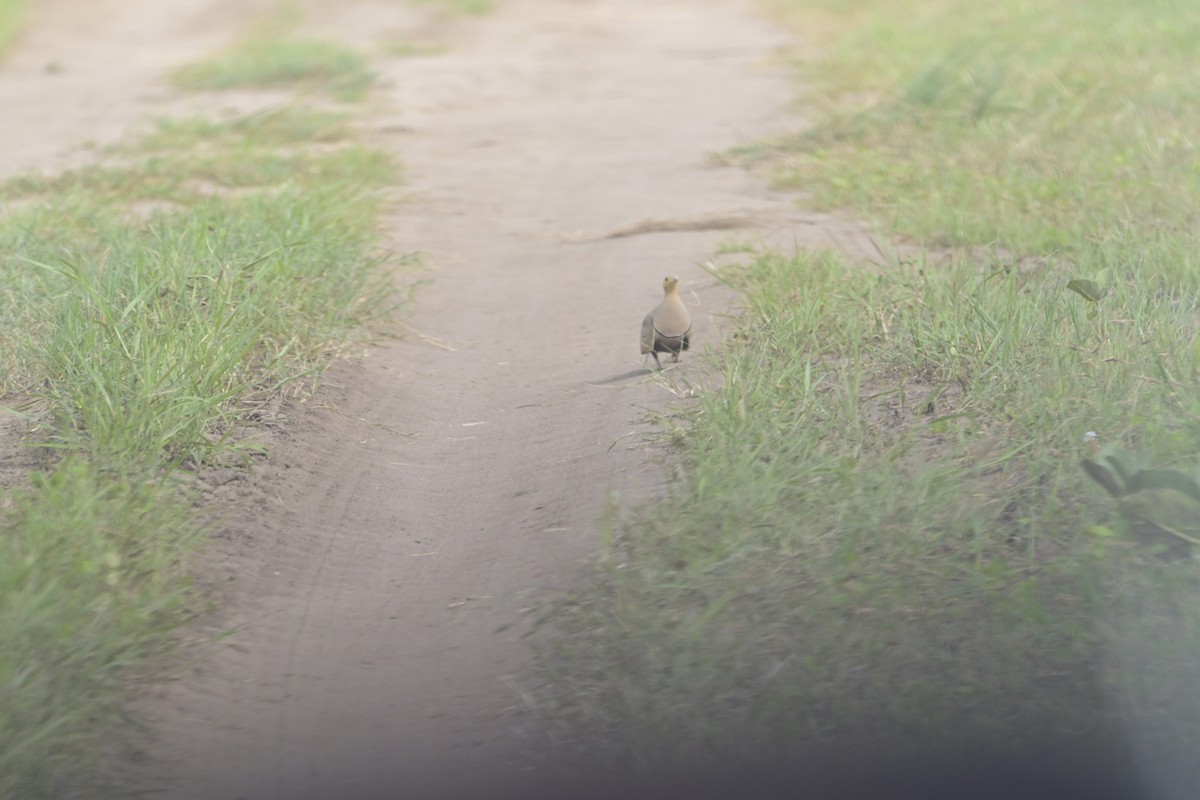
18 187 388 469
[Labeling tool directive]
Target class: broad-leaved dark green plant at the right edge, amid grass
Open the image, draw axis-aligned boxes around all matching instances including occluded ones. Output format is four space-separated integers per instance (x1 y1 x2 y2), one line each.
1082 434 1200 554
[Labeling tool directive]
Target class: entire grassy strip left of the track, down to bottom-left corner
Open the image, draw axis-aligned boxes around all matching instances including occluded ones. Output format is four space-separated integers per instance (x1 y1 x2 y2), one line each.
0 107 397 798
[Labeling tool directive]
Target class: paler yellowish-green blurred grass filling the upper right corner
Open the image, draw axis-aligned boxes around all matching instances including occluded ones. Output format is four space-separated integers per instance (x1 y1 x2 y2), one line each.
776 0 1200 260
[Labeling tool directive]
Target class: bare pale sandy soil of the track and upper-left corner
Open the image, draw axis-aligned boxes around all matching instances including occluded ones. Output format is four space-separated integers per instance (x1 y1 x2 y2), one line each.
0 0 868 800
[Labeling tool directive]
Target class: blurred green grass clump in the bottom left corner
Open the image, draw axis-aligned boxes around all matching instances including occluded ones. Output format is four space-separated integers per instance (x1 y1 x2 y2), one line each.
0 458 199 798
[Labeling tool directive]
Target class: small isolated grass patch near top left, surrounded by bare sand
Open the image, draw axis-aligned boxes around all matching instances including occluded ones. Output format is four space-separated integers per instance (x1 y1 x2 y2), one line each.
174 37 376 101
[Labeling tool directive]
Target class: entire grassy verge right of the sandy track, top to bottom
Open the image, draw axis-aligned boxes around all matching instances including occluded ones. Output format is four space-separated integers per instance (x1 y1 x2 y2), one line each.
541 0 1200 796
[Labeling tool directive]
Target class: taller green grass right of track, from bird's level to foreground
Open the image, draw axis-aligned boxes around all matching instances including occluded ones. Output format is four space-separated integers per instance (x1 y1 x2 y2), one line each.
542 253 1200 786
